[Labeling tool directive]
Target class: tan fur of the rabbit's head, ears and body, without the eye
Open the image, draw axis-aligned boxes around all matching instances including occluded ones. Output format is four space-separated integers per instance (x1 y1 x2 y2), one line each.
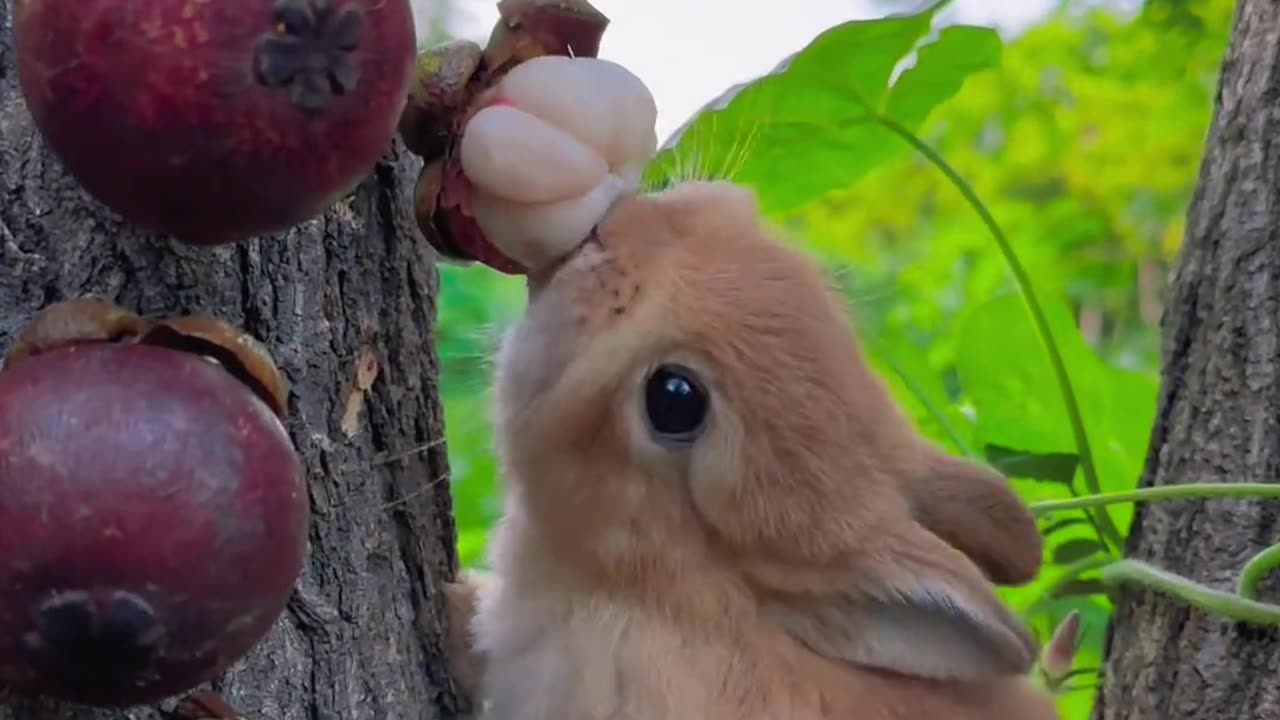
451 182 1057 720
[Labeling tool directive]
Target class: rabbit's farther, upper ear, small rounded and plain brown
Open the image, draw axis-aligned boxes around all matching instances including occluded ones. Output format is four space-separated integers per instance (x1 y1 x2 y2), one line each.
902 446 1044 585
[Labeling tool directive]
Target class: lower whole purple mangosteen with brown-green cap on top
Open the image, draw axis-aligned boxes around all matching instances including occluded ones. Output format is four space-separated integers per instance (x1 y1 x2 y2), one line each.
0 299 310 707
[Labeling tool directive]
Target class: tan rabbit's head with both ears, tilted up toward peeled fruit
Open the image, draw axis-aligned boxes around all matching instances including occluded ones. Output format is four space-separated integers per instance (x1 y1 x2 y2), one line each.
497 182 1041 679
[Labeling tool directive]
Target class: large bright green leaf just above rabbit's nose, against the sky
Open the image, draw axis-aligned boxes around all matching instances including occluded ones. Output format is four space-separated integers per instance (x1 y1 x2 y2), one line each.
648 4 1002 215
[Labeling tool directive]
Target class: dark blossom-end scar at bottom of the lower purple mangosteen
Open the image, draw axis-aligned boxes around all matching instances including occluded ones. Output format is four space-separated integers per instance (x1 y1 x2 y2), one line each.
22 591 166 692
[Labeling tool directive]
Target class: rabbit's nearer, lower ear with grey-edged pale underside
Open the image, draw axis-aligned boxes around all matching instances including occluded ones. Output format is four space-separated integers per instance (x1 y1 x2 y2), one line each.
762 524 1038 680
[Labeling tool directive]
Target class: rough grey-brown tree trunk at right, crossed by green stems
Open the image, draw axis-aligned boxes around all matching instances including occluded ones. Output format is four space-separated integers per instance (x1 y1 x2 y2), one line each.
1094 0 1280 720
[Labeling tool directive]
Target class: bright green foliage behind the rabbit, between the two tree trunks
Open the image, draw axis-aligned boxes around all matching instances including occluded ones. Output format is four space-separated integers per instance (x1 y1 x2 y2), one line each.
439 0 1234 720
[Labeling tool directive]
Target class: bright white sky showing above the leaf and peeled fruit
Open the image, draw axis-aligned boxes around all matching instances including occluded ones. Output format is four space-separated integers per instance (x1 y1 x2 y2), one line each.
435 0 1057 142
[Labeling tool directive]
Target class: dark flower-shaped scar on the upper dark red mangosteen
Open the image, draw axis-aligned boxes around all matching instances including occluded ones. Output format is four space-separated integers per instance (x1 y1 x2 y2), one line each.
255 0 365 114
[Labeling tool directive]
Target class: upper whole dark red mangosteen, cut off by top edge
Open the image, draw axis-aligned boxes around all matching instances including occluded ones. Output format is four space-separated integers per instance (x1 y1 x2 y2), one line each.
14 0 416 245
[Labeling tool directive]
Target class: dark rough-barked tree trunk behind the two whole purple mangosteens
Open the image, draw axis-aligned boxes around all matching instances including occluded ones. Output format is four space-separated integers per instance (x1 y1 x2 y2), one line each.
0 0 457 720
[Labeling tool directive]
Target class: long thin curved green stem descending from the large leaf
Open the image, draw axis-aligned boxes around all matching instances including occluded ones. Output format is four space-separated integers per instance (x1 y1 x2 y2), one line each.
876 115 1124 550
